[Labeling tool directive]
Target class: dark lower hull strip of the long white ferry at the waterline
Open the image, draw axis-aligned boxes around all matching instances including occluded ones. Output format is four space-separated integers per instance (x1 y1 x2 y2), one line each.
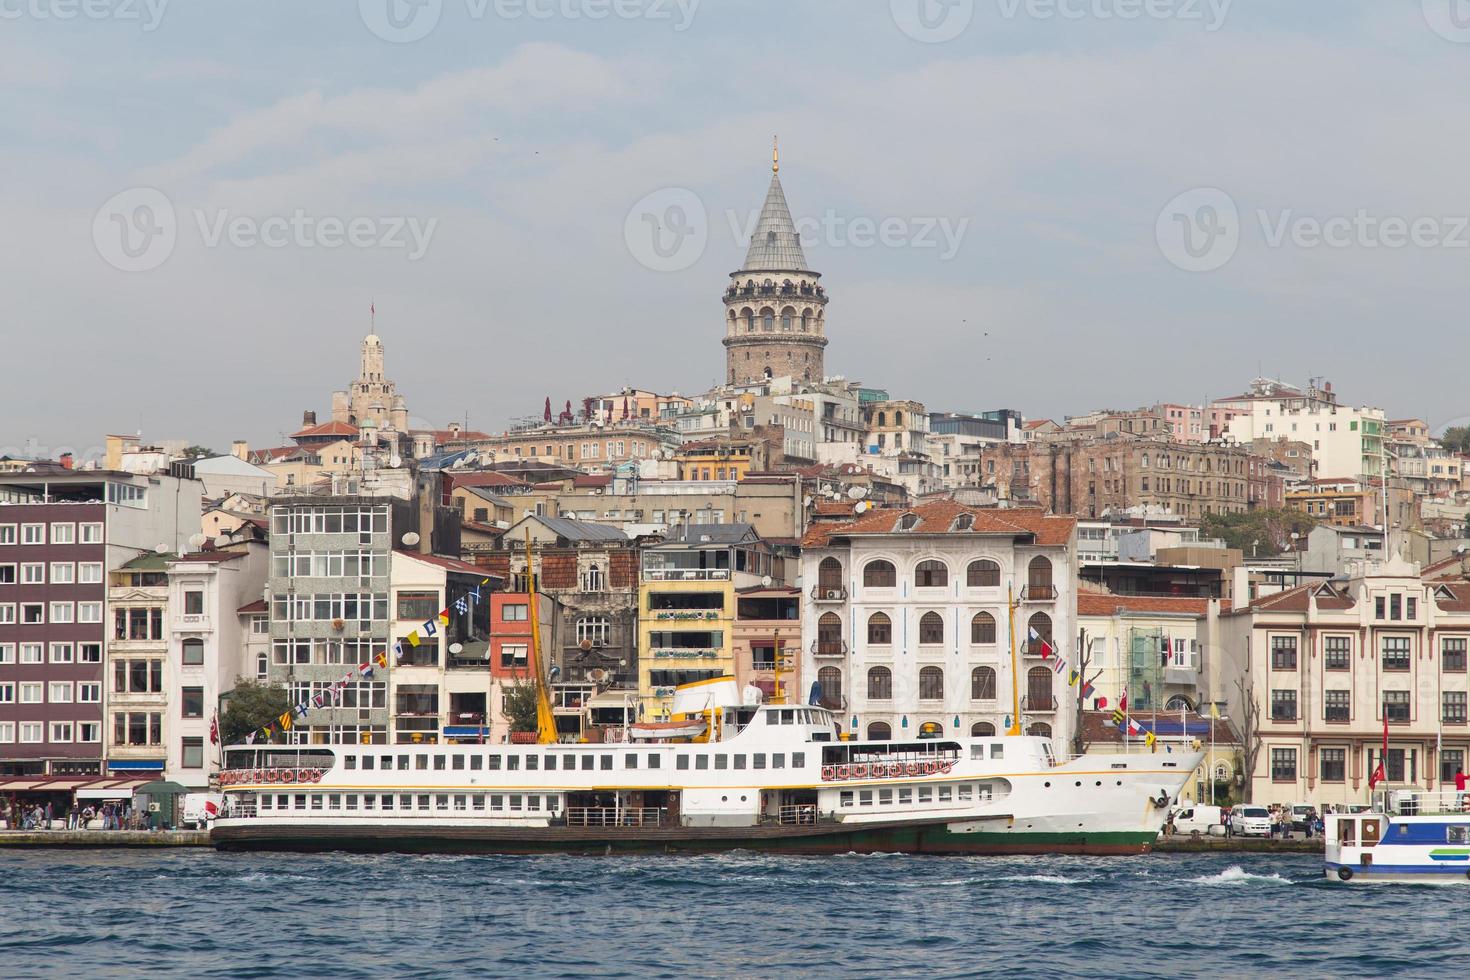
212 821 1155 855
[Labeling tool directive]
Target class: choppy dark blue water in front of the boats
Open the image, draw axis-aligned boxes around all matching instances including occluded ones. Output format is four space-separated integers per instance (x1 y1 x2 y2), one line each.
0 851 1470 980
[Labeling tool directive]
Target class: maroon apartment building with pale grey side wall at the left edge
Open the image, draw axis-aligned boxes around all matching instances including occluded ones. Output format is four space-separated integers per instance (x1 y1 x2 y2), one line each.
0 463 201 777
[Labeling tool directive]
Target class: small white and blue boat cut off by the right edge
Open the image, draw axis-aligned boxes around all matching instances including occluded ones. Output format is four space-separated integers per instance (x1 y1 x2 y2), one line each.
1324 790 1470 883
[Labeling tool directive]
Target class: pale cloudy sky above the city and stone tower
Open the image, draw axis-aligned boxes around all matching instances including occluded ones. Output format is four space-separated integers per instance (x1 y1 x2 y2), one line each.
0 0 1470 454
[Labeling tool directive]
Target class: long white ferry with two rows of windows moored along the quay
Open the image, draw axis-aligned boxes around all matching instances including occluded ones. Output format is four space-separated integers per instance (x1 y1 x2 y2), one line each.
212 679 1200 854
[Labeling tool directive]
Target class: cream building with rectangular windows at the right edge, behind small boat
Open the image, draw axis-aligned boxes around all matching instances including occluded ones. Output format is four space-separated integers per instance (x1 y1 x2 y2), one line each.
1222 555 1470 805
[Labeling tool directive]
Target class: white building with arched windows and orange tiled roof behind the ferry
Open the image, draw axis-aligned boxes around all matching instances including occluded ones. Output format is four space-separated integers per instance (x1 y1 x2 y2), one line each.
801 501 1076 749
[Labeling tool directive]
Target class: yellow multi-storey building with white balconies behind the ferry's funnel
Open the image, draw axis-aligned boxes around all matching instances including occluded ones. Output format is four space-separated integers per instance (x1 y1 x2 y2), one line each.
638 525 784 718
